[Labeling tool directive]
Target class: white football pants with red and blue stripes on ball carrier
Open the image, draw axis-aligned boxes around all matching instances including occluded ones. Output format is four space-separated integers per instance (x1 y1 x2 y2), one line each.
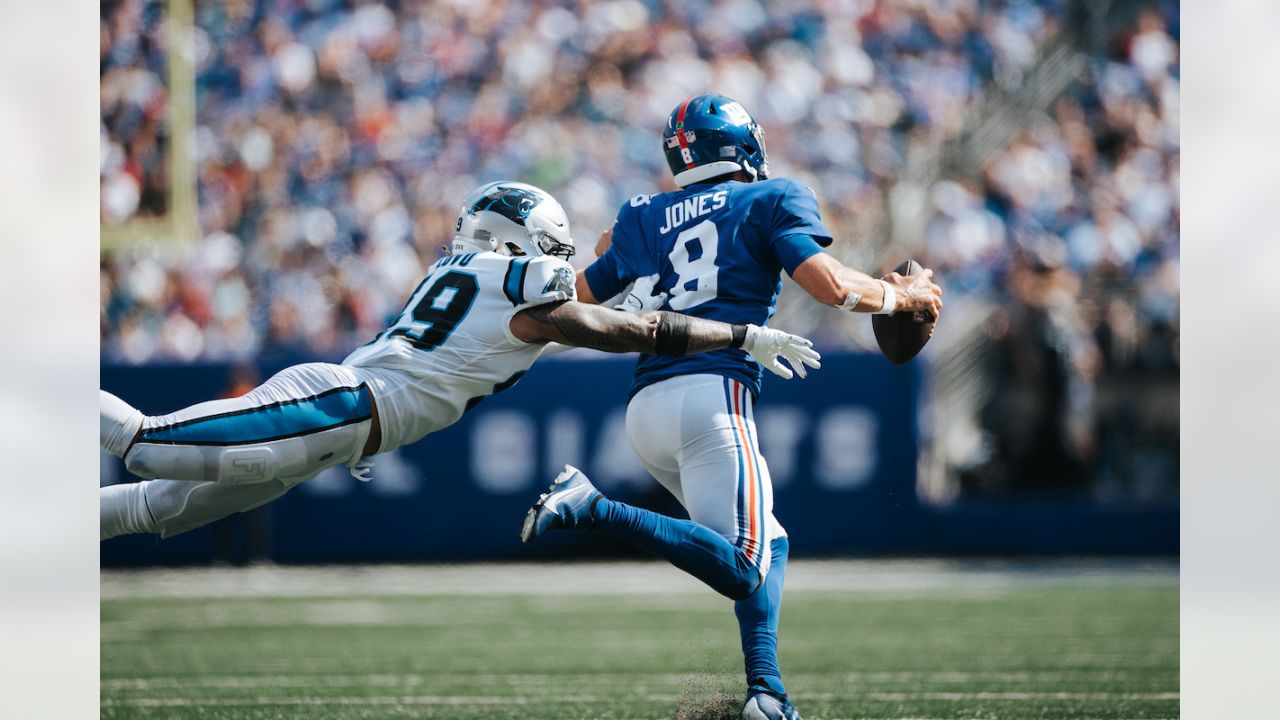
627 374 786 577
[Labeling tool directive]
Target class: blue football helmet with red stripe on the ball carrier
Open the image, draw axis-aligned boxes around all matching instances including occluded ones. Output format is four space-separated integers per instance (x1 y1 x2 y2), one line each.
662 92 769 187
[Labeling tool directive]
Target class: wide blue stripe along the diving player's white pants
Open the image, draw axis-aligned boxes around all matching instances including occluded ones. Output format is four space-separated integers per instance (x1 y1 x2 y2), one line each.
141 386 372 445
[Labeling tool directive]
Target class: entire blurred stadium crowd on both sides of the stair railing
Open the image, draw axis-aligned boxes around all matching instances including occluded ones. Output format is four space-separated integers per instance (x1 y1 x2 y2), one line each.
101 0 1179 491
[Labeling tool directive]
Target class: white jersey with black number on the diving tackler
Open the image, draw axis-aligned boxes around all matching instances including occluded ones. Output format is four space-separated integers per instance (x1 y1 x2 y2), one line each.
342 252 575 451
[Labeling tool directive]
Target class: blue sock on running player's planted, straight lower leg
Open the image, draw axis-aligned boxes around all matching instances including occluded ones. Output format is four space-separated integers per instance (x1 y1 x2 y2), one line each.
733 538 790 697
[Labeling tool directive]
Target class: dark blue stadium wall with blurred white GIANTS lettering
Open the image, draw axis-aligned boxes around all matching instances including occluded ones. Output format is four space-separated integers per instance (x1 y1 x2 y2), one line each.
101 354 1178 566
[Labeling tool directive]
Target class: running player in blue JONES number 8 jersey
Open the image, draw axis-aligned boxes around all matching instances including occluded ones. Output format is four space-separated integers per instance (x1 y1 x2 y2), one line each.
521 94 942 720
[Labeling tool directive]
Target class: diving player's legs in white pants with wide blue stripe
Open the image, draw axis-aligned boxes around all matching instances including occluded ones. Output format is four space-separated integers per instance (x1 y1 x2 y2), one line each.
99 363 372 539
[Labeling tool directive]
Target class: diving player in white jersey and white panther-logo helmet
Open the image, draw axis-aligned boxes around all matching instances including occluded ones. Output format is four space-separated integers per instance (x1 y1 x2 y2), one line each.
100 182 818 539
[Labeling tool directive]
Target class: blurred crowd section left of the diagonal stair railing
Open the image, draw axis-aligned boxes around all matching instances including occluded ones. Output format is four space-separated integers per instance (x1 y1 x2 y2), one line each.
102 0 1057 363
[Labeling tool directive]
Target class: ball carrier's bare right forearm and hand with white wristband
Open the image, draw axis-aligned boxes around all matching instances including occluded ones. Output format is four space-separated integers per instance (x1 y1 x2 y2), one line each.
791 252 942 316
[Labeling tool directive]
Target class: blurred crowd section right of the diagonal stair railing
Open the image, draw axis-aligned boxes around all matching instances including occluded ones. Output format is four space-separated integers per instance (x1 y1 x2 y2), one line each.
925 9 1179 497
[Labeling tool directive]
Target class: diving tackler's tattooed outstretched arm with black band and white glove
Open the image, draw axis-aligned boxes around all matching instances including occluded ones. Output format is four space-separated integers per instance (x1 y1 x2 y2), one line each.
511 300 820 378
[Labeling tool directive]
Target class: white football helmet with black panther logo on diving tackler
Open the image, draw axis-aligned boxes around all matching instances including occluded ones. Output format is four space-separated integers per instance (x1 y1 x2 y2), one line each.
453 181 575 259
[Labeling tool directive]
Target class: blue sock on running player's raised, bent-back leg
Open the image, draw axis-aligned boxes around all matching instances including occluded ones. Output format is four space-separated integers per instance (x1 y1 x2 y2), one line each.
591 497 760 600
